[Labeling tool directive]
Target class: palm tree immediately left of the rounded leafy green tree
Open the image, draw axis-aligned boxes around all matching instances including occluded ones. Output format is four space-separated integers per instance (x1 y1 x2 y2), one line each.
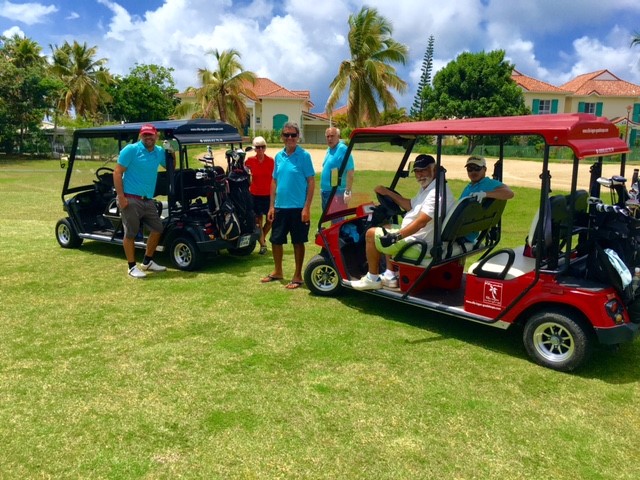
51 41 115 118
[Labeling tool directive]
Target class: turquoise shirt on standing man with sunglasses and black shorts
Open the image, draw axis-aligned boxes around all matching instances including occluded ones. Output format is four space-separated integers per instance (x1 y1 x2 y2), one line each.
273 145 316 208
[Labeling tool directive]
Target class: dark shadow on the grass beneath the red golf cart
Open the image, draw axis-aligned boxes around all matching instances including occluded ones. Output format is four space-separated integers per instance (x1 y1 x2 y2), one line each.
338 290 640 384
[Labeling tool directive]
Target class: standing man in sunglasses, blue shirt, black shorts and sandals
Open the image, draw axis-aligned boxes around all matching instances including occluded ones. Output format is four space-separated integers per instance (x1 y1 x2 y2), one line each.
261 122 316 290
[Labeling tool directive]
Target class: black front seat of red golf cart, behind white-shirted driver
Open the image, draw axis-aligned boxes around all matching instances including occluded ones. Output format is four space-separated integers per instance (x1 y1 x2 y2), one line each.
393 197 507 266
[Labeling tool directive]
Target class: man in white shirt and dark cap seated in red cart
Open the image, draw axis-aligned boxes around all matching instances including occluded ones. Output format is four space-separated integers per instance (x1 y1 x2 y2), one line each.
351 154 454 290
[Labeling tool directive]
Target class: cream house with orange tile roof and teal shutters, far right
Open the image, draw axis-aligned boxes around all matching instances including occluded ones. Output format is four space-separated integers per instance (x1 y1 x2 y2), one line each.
511 69 640 145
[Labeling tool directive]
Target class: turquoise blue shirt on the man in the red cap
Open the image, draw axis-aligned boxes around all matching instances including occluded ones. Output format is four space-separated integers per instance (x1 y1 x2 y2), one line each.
118 141 167 198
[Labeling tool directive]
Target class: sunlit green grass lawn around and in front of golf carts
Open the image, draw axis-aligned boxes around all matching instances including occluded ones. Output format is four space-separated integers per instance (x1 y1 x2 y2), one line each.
0 161 640 480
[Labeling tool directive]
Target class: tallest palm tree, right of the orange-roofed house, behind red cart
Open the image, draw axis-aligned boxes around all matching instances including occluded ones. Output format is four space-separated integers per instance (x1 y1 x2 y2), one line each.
326 7 408 127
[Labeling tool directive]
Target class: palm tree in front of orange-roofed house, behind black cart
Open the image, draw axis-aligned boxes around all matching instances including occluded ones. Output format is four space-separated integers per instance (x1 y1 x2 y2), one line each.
176 49 256 130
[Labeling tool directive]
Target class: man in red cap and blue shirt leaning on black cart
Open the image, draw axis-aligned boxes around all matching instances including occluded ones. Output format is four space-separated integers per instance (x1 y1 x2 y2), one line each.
113 123 167 278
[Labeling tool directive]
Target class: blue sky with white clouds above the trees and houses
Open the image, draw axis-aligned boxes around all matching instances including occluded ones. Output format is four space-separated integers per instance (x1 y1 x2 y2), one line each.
0 0 640 112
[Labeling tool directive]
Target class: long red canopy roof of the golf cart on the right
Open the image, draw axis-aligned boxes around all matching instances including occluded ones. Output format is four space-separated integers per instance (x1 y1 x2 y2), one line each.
351 113 629 158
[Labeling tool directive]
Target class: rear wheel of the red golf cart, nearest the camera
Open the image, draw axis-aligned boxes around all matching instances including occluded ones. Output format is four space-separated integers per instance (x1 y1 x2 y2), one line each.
522 310 593 372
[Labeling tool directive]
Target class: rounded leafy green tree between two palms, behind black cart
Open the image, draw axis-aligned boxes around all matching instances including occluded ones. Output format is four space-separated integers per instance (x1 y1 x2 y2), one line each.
107 64 178 122
